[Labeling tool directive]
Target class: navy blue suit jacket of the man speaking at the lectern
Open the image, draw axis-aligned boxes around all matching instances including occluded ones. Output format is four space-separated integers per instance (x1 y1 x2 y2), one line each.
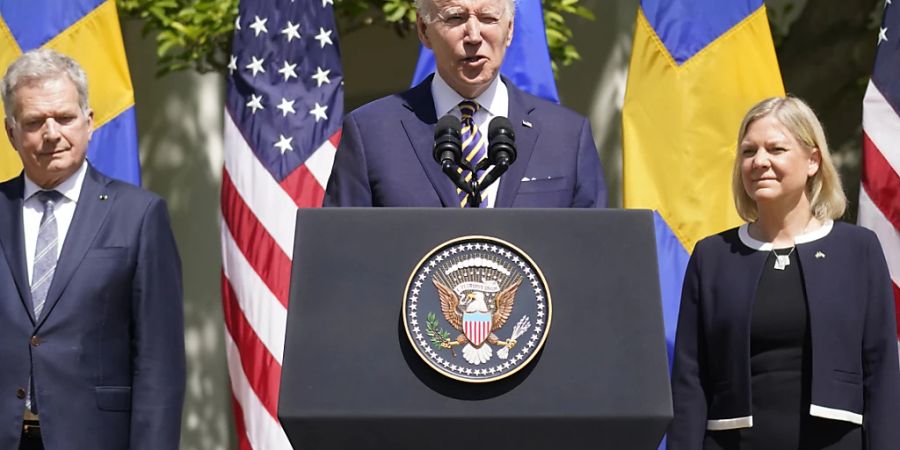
325 75 606 208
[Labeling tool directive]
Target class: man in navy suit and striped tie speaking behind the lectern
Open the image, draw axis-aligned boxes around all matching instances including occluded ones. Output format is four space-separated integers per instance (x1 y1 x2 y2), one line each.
325 0 606 208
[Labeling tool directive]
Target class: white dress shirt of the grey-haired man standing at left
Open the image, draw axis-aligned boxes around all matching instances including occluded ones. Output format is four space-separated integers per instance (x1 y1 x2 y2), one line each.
22 161 87 284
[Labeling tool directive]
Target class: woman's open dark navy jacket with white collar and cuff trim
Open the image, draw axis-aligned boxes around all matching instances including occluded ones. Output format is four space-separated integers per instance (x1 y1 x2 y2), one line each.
667 222 900 450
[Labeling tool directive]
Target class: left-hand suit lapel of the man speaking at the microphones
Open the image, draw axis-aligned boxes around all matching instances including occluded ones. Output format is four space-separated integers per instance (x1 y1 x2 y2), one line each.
401 75 458 207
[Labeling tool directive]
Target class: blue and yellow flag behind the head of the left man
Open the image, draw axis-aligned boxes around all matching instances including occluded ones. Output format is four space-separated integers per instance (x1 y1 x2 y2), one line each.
0 0 141 184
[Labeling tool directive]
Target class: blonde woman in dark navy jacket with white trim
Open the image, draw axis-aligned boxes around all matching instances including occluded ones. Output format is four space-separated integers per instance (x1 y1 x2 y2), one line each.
668 97 900 450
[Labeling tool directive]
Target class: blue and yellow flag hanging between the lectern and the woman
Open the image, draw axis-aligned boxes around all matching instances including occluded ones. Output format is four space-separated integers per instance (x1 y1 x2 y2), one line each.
622 0 784 361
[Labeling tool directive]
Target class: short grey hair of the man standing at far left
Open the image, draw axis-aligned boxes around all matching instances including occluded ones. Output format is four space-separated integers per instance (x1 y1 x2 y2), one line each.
0 48 90 121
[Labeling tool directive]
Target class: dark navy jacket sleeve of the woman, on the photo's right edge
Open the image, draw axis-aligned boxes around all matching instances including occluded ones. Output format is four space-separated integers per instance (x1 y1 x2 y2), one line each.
863 233 900 450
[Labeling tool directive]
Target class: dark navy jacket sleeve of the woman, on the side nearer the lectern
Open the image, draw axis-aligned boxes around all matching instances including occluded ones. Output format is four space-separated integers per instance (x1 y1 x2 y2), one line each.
666 249 707 450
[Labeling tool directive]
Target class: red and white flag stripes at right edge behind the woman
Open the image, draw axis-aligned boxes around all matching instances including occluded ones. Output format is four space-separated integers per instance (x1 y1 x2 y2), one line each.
859 81 900 352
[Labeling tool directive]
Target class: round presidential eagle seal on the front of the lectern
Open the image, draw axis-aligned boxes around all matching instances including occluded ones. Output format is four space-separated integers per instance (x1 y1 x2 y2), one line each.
403 236 551 383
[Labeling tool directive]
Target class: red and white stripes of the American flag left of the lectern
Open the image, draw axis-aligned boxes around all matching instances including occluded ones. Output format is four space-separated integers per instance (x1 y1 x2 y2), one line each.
221 111 340 450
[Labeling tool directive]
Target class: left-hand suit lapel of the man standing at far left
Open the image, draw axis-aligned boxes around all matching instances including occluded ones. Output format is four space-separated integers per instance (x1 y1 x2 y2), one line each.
0 175 34 322
